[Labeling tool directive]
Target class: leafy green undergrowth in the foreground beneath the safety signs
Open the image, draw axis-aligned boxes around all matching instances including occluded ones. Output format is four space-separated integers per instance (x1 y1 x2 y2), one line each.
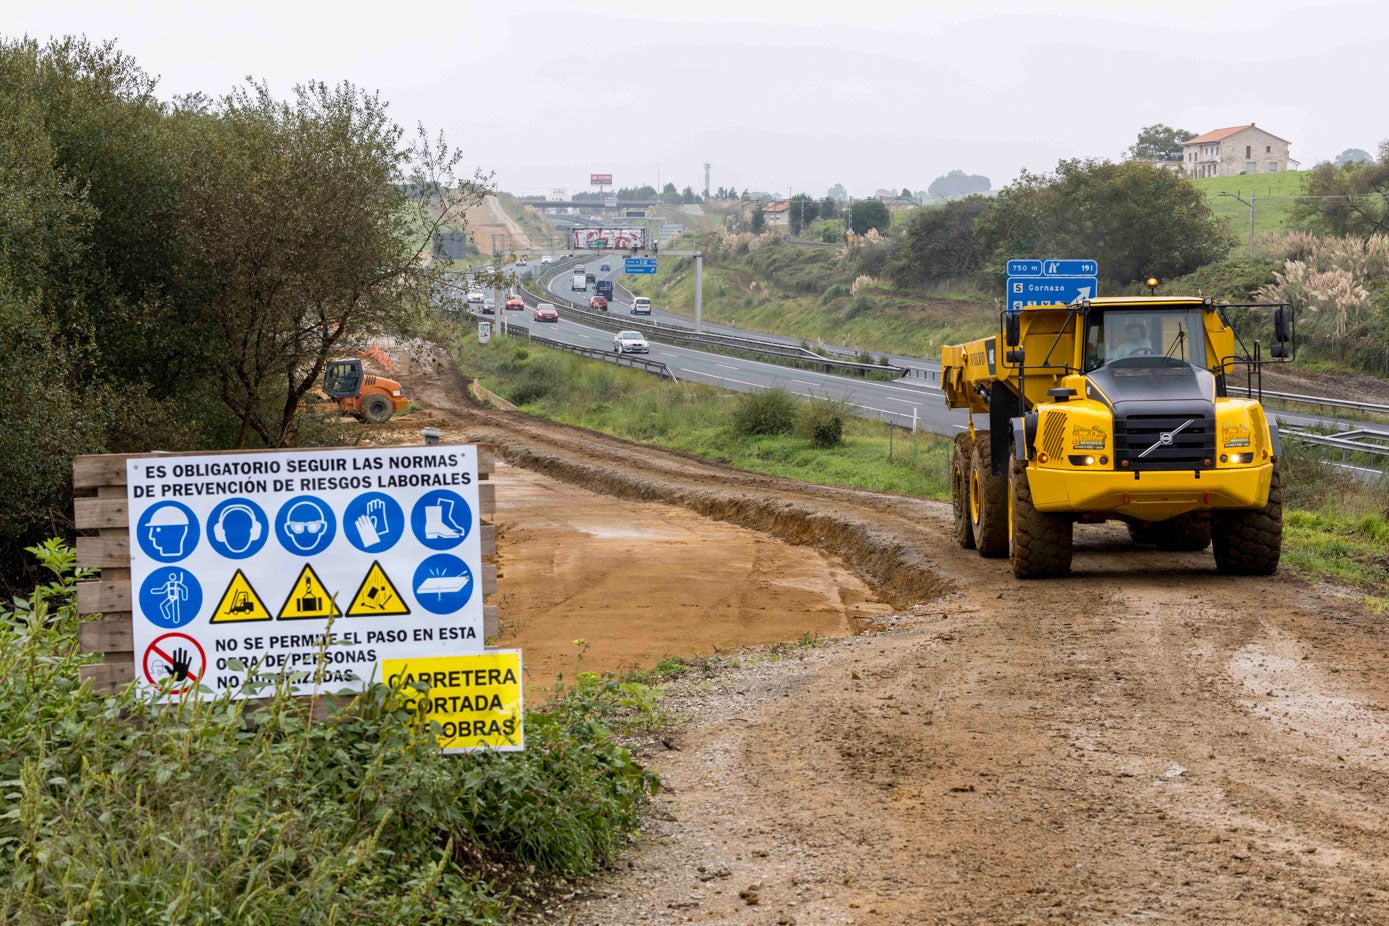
0 541 657 926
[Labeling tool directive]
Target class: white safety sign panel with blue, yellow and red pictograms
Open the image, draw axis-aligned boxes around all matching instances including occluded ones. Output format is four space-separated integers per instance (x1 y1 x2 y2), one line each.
126 446 482 694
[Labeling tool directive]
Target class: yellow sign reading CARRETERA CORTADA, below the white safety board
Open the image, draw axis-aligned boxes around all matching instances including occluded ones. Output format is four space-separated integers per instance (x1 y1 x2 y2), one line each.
381 650 525 752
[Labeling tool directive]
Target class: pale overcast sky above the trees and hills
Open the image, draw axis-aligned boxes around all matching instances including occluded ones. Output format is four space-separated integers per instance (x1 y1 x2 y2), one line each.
13 0 1389 196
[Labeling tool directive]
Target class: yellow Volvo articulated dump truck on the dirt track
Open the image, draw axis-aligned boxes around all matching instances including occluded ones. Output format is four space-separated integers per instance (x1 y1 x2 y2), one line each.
940 296 1293 579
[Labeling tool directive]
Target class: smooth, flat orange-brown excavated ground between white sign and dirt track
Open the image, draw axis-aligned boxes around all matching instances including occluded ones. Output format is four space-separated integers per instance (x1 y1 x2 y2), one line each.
493 465 892 702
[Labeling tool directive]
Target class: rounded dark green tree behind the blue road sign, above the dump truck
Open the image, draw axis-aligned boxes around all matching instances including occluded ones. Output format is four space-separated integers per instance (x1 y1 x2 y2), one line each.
975 160 1233 286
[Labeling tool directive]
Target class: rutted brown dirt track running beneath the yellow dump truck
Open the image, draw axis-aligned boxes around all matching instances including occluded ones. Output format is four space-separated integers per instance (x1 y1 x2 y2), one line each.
380 344 1389 926
